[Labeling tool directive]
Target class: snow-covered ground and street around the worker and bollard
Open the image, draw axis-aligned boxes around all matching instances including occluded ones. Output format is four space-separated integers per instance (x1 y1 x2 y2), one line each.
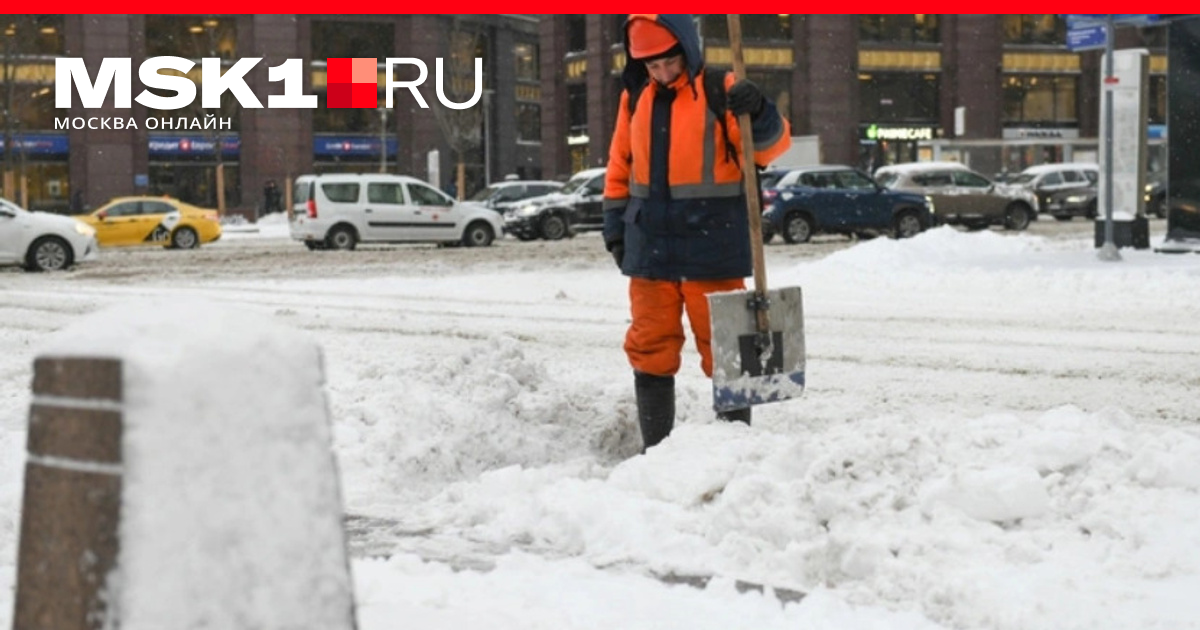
0 217 1200 630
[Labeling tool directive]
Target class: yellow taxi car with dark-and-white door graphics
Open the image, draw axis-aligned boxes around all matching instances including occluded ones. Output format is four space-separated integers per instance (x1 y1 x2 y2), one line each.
76 197 221 250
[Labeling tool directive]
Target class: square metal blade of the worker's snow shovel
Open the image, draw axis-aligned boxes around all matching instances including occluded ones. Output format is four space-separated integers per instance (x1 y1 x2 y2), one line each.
708 287 804 412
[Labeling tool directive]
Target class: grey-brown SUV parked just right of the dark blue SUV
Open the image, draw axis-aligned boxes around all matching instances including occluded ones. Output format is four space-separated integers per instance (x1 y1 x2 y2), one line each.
875 162 1038 230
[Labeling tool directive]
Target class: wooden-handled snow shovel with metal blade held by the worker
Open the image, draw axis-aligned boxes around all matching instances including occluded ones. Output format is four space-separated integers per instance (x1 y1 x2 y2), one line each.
708 16 804 412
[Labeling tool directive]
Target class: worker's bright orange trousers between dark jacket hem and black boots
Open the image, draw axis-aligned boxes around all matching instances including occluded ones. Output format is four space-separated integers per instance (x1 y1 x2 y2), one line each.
625 277 745 378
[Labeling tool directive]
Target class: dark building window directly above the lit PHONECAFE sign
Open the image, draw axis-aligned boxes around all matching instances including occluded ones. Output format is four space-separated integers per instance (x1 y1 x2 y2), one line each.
858 72 940 124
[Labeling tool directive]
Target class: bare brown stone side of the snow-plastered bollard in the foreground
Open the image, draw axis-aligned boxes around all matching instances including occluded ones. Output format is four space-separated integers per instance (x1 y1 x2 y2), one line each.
13 358 122 630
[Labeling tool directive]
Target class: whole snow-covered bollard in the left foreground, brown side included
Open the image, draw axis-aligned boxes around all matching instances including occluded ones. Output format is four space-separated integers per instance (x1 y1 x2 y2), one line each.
13 300 356 630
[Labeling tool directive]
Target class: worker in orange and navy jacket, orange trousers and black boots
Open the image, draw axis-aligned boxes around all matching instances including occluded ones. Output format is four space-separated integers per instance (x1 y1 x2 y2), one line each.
604 14 791 448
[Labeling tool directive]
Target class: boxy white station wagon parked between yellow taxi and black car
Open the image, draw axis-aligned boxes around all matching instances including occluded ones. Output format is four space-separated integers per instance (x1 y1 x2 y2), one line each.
288 173 503 250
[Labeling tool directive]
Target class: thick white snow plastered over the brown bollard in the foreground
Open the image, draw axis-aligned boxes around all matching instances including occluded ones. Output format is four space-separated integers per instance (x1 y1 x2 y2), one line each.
44 300 353 629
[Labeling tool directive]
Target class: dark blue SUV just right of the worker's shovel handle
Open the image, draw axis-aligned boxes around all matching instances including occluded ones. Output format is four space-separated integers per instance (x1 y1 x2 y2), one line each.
763 166 934 242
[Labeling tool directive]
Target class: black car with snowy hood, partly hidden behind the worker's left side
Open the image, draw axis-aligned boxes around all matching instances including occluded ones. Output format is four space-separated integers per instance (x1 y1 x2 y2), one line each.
504 168 605 241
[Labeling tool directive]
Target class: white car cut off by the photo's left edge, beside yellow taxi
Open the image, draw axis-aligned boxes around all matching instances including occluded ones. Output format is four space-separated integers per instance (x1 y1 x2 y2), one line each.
0 198 98 271
